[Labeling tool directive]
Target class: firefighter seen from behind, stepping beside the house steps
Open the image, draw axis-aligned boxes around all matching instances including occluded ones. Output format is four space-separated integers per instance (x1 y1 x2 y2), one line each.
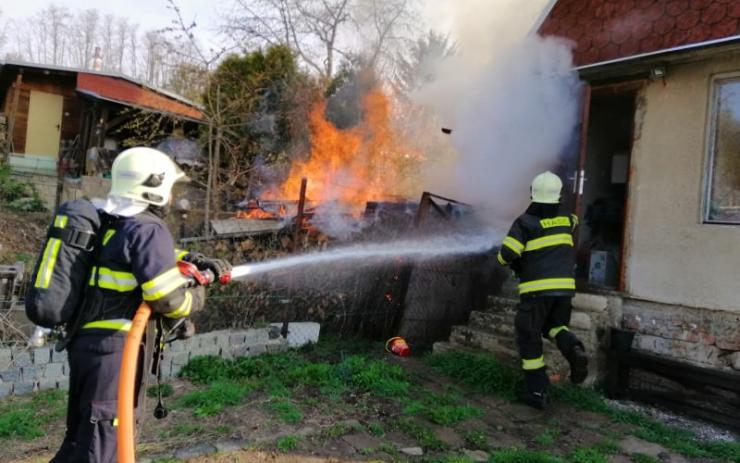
498 171 588 408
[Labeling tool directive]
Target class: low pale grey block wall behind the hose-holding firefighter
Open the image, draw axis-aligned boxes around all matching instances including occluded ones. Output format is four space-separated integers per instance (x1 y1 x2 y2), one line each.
0 324 292 397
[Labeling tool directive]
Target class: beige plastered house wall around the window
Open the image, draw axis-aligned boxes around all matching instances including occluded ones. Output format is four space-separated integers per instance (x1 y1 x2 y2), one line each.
626 54 740 313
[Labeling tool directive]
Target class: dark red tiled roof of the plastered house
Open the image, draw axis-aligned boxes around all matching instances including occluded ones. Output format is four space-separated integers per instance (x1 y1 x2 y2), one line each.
539 0 740 66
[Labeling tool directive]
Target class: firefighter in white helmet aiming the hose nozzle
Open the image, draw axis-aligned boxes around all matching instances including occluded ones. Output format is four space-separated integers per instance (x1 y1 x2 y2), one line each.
52 148 231 463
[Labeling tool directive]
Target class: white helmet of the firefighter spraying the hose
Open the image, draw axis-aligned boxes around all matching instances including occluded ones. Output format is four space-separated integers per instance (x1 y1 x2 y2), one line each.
110 147 185 206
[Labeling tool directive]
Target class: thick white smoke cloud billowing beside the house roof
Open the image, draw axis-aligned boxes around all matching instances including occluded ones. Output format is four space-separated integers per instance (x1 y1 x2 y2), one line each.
414 0 580 236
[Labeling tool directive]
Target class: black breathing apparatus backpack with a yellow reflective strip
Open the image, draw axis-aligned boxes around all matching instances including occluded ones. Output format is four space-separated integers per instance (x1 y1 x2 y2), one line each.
26 199 107 331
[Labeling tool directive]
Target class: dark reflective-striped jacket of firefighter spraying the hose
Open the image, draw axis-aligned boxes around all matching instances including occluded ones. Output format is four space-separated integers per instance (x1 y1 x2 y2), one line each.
80 211 203 334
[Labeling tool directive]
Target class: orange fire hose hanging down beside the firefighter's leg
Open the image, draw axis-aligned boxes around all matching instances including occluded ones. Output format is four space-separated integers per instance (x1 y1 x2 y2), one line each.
116 303 152 463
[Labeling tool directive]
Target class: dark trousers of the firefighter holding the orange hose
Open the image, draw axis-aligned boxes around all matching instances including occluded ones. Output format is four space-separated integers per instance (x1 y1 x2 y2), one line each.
50 332 141 463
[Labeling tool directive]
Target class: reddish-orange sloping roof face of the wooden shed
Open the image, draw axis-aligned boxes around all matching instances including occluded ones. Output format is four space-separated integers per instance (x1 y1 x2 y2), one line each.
77 72 203 120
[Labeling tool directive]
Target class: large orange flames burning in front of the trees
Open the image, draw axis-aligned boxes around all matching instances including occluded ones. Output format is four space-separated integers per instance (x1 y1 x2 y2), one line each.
263 89 421 213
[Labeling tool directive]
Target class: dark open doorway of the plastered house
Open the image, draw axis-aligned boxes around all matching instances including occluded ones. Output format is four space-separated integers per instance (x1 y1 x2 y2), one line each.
571 82 642 290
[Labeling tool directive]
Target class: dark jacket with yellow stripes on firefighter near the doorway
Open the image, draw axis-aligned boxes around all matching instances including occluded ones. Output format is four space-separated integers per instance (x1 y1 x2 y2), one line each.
498 203 578 298
